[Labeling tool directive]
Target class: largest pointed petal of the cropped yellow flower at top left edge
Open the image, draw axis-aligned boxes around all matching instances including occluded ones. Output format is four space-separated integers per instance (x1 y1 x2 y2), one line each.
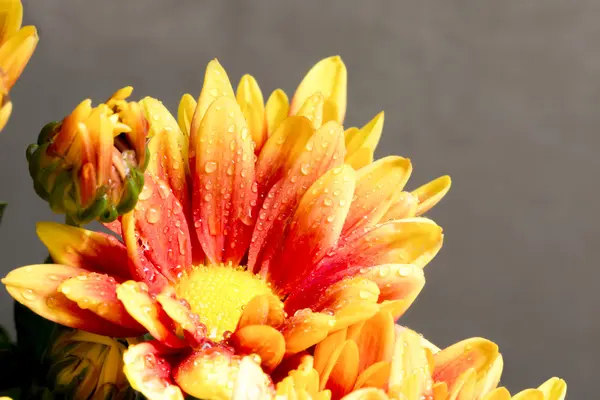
0 26 39 89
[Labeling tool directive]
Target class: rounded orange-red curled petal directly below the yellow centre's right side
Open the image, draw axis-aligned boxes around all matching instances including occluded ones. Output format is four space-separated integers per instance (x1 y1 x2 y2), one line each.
231 325 285 372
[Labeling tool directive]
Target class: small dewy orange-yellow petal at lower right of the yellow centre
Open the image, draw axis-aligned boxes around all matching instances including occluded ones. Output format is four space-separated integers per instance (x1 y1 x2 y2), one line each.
281 309 335 356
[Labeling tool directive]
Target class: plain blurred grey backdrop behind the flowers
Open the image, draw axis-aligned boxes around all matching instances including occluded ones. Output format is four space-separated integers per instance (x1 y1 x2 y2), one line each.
0 0 600 399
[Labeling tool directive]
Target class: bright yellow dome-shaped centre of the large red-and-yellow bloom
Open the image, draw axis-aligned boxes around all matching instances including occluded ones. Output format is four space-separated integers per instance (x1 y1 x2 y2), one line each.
175 264 271 340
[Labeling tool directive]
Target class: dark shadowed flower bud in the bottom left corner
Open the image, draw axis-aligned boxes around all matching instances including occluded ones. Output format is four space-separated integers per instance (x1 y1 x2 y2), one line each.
44 330 135 400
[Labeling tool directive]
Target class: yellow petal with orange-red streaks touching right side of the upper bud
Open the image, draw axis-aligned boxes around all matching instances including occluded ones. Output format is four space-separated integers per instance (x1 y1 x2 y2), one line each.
140 97 190 210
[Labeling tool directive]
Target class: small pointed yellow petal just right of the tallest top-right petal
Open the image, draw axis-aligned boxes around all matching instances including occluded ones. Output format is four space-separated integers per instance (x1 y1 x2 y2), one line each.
345 111 384 169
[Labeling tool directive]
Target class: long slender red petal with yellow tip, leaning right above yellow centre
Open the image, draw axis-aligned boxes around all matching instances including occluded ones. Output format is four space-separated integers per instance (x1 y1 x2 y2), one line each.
248 122 344 275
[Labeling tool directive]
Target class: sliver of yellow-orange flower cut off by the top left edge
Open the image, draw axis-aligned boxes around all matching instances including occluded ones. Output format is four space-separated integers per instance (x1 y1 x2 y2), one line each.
0 0 38 130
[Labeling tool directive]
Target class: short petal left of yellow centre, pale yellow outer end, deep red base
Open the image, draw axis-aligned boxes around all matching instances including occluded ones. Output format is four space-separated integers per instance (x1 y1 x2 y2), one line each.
117 281 186 348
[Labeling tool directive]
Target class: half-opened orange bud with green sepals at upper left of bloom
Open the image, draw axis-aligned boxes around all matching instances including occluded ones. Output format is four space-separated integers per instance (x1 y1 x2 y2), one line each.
27 87 149 225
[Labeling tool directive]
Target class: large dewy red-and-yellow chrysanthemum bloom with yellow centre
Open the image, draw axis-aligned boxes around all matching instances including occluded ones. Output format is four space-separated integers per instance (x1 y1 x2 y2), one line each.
3 57 450 399
